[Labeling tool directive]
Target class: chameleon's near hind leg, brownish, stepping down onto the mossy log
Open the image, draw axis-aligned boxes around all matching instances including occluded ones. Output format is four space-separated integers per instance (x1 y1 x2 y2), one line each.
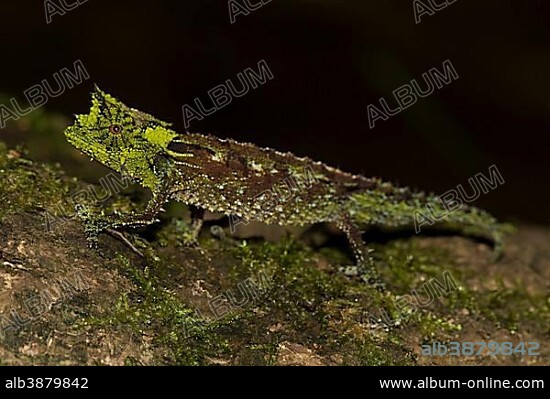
336 215 383 288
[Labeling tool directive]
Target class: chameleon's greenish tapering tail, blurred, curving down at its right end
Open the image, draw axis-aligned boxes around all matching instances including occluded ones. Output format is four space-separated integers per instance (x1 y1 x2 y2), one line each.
348 187 514 260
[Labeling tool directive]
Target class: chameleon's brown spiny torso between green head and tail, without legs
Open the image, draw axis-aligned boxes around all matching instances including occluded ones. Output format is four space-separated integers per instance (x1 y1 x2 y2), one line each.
168 134 376 225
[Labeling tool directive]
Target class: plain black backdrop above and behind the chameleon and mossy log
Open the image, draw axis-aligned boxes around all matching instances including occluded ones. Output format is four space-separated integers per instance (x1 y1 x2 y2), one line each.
0 0 550 223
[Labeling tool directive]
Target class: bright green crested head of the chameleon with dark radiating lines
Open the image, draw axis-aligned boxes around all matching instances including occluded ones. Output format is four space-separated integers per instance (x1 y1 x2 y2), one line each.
65 87 176 188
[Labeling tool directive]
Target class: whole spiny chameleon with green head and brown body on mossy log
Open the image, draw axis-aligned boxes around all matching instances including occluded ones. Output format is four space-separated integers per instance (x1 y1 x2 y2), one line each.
64 86 505 284
